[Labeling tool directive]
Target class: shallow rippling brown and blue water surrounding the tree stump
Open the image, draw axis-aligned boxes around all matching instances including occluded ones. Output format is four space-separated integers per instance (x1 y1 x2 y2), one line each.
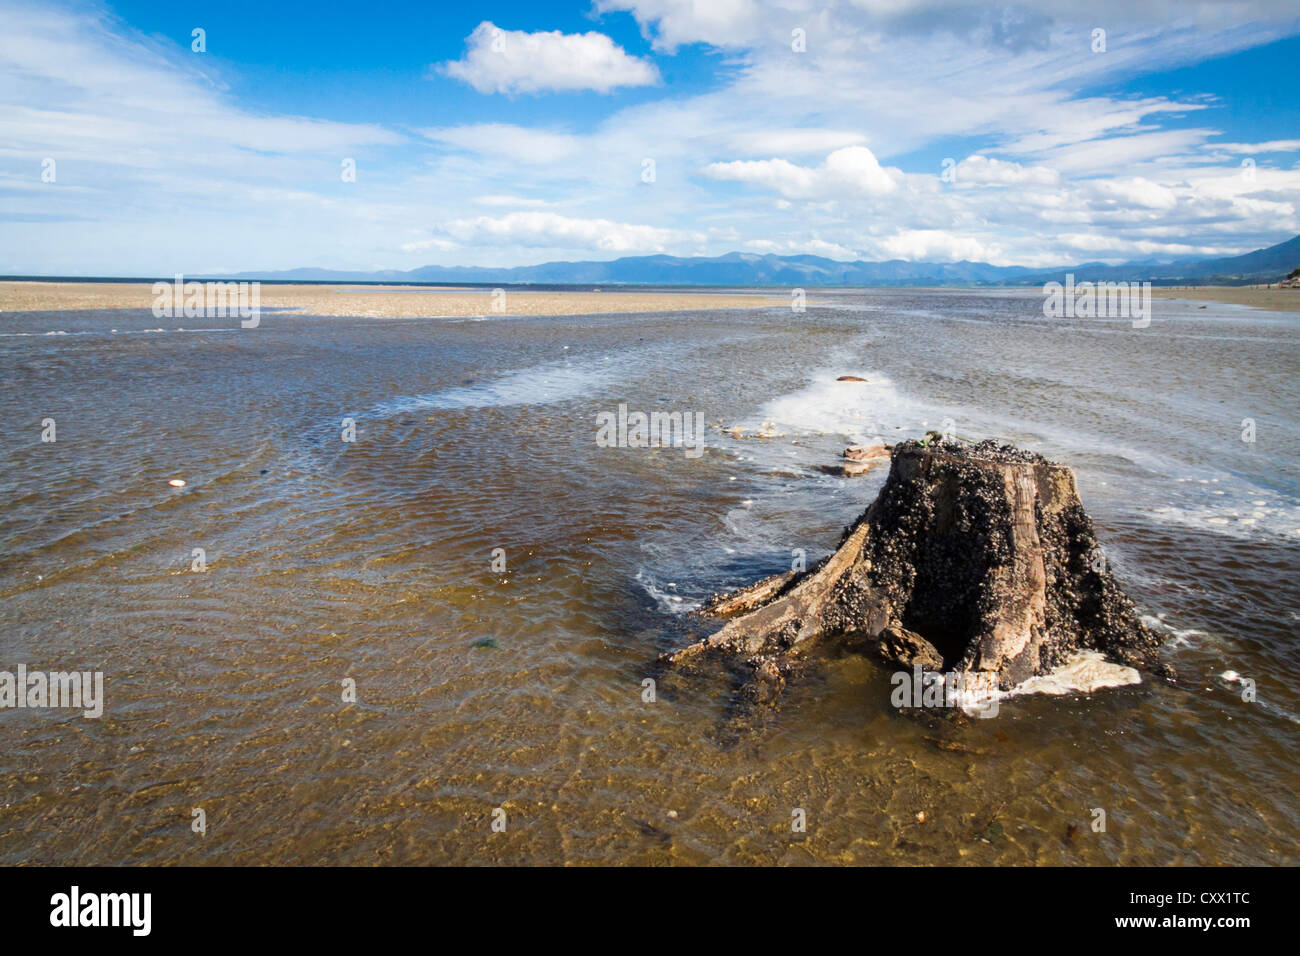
0 290 1300 864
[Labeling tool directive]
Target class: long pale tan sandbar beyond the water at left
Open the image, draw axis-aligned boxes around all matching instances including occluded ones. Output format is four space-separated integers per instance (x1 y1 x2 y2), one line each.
0 282 790 319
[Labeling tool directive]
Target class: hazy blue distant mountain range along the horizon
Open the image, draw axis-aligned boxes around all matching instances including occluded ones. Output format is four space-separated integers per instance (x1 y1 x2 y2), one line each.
234 235 1300 286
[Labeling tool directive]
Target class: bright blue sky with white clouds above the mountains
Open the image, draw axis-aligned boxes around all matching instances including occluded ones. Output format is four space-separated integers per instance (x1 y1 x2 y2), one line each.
0 0 1300 276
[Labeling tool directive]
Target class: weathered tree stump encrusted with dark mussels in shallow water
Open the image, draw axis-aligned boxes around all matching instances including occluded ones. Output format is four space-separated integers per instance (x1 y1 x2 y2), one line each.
666 437 1160 689
